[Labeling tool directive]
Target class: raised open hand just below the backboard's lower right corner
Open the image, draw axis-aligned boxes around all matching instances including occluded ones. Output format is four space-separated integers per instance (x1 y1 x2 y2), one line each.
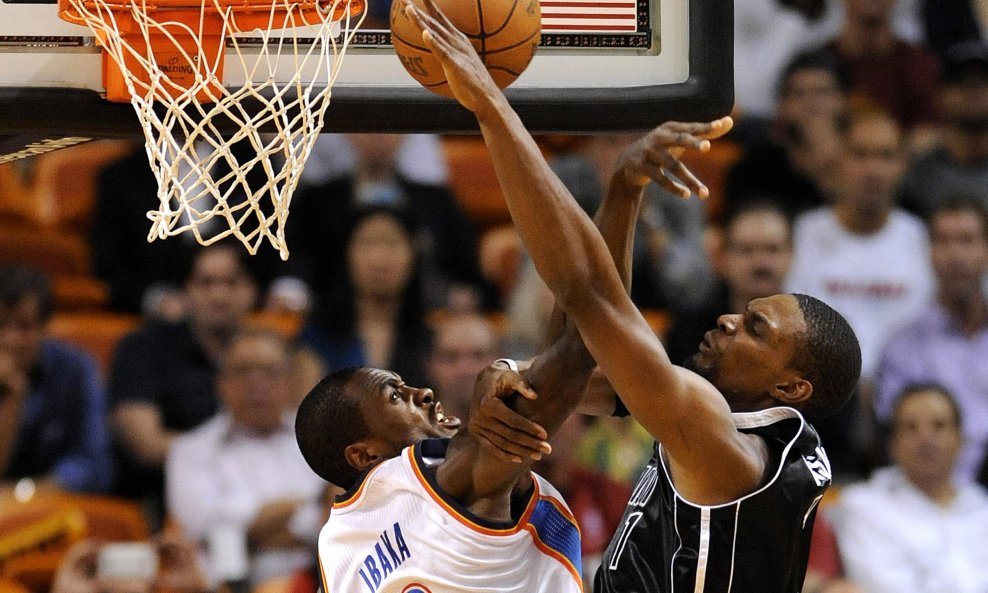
616 117 734 198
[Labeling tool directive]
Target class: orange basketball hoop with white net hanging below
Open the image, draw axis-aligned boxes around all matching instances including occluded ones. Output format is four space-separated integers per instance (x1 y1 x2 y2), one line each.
59 0 364 259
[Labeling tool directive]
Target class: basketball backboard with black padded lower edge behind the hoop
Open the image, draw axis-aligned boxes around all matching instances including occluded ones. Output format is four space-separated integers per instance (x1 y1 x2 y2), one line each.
0 0 733 157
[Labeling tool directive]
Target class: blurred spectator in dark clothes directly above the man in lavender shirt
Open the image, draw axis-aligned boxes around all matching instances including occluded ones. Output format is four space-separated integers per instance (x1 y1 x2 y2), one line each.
899 41 988 217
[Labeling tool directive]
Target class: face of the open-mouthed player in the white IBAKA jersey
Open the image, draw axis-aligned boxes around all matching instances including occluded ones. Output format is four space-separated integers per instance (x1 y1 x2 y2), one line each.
353 369 460 455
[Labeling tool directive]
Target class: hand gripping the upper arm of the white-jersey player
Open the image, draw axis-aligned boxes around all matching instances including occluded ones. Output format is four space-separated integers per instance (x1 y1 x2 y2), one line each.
469 365 552 463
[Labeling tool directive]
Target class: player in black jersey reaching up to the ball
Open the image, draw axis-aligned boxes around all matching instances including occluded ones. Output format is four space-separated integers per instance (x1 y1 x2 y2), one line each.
405 0 861 593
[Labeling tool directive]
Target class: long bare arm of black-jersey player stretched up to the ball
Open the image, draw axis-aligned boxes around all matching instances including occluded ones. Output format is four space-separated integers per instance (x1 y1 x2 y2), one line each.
406 0 765 504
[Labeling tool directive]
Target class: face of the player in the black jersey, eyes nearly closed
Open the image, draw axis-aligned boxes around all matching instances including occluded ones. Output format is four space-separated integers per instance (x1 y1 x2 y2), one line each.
689 295 806 412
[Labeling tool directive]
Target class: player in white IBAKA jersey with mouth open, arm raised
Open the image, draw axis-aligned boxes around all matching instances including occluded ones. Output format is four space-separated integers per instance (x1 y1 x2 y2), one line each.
296 111 716 593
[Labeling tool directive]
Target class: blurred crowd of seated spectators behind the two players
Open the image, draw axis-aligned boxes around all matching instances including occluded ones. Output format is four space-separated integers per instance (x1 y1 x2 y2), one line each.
0 0 988 593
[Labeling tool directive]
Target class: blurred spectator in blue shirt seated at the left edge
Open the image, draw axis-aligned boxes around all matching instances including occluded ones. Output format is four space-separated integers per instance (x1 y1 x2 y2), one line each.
0 264 112 498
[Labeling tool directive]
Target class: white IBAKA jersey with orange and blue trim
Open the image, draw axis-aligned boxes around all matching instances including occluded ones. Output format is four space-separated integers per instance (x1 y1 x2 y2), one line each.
319 441 583 593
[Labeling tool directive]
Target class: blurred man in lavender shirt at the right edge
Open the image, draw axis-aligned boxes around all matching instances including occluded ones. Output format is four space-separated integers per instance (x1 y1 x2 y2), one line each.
875 196 988 481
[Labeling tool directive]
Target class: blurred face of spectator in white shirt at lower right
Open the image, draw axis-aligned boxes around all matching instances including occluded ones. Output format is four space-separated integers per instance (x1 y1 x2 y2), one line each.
890 390 961 485
